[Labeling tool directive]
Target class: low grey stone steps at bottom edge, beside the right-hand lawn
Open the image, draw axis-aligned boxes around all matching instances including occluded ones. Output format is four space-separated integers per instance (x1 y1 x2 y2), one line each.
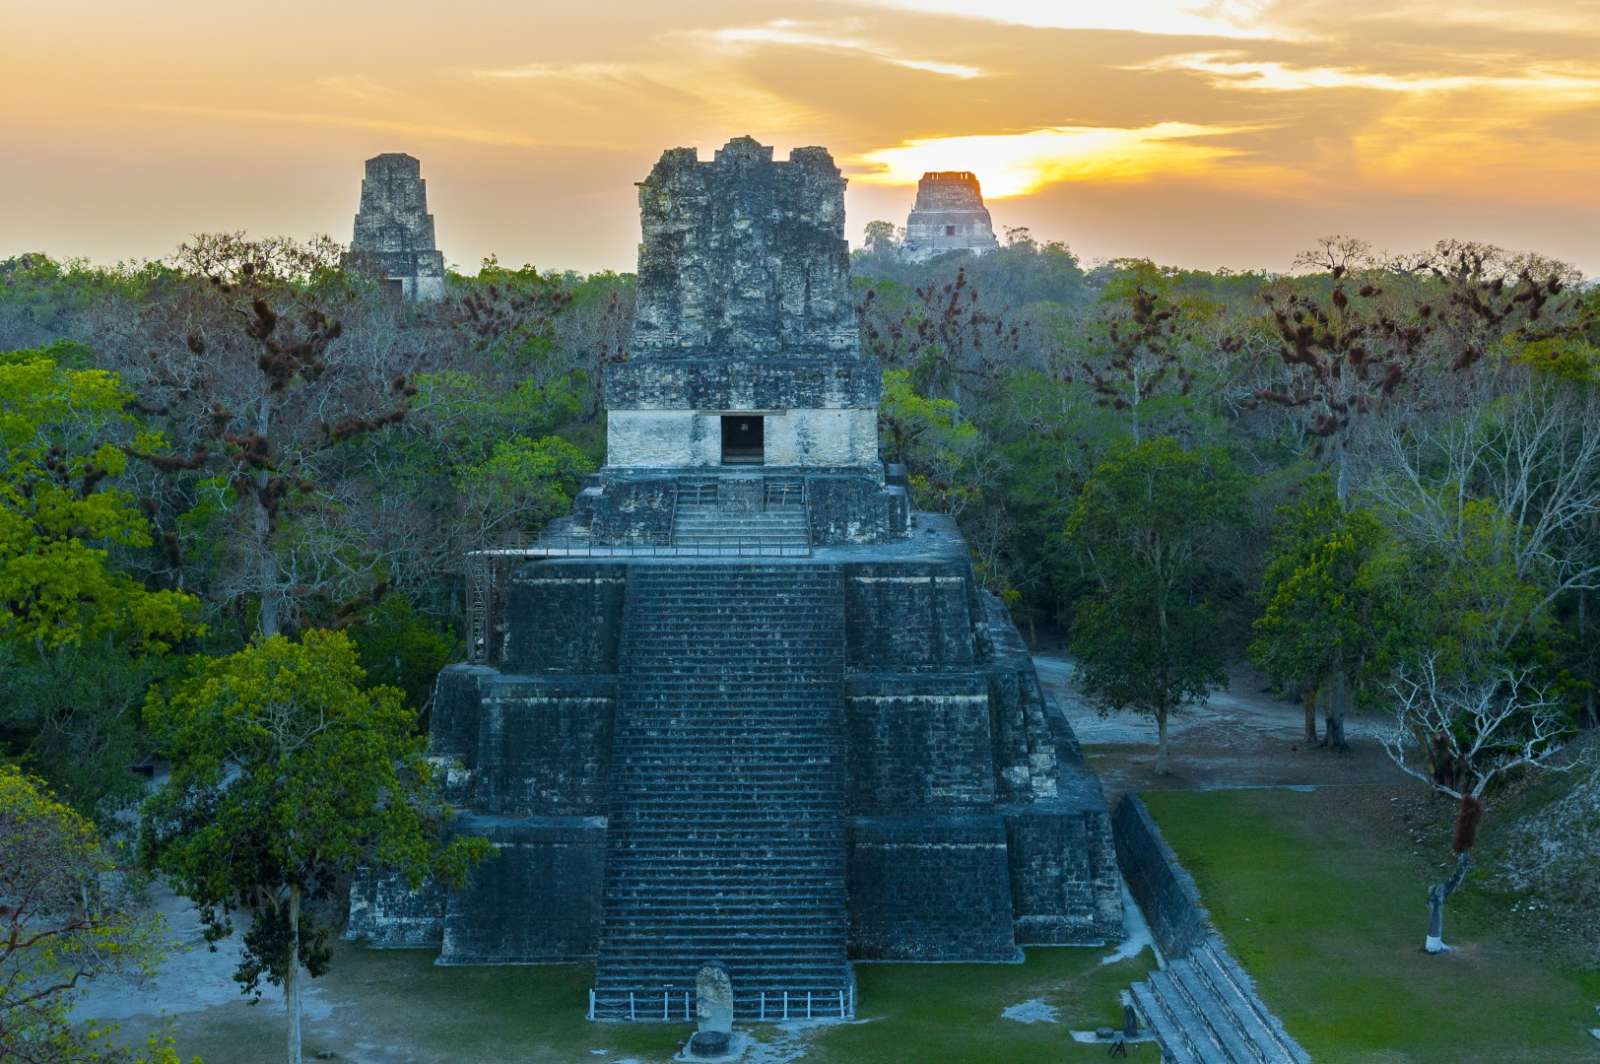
1133 934 1310 1064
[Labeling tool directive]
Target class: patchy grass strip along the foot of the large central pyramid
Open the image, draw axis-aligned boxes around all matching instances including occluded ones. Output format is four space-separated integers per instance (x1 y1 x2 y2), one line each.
122 942 1158 1064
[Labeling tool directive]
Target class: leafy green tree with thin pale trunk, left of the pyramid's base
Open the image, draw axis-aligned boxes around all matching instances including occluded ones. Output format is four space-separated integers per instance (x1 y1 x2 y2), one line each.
141 629 488 1064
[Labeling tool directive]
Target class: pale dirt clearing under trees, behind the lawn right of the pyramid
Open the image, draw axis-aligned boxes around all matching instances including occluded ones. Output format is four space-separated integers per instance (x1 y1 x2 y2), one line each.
1034 654 1402 802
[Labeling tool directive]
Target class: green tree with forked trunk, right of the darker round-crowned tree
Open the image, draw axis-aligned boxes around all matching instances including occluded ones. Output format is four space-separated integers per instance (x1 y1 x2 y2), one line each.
1250 474 1400 749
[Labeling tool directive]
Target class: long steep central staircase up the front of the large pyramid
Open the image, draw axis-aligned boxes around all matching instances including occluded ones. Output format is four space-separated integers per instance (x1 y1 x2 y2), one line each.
592 562 854 1021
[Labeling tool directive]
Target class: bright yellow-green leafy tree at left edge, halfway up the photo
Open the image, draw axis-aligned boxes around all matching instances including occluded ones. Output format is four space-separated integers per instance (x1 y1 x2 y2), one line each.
0 344 200 808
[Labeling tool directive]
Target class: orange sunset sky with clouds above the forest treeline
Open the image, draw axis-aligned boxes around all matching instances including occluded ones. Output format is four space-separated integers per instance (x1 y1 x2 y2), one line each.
0 0 1600 277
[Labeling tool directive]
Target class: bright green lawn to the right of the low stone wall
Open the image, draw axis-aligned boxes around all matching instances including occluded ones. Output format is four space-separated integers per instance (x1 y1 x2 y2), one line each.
1144 786 1600 1064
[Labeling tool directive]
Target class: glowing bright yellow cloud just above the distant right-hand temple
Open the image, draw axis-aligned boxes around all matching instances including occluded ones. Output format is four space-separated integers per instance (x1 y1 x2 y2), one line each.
850 122 1248 198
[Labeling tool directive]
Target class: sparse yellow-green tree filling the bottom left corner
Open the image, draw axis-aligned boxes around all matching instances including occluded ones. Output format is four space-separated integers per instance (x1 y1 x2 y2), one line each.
0 763 178 1064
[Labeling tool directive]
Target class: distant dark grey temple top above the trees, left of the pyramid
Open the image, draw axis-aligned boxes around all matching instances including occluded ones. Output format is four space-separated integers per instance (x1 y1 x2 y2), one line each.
349 152 445 299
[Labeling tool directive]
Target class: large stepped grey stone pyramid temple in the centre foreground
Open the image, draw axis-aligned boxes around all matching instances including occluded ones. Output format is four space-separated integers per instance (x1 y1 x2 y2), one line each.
349 138 1123 1022
